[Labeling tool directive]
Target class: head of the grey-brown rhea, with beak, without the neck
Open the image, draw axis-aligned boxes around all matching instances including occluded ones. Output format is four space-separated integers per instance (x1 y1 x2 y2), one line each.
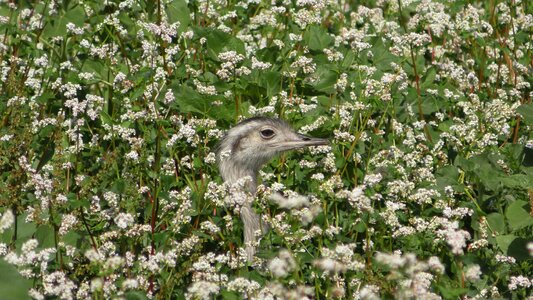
217 117 329 180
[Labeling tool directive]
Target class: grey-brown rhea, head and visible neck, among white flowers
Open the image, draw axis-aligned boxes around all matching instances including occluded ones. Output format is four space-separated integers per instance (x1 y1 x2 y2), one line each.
216 116 329 262
